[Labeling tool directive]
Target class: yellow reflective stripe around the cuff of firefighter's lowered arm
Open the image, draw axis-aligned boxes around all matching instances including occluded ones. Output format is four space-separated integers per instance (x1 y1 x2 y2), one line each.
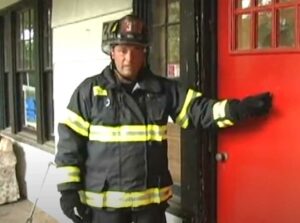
56 166 80 184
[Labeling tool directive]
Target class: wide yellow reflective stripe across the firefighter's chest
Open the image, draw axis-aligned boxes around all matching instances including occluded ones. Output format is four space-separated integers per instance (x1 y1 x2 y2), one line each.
89 125 167 142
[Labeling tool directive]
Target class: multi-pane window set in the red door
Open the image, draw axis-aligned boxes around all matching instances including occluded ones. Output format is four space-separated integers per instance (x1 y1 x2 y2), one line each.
231 0 300 52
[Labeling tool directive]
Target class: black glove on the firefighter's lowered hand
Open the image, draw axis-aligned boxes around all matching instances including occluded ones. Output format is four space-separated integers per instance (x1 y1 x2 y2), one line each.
60 190 92 223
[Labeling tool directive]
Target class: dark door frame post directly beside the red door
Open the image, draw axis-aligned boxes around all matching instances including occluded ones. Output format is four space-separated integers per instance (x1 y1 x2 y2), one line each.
195 0 218 223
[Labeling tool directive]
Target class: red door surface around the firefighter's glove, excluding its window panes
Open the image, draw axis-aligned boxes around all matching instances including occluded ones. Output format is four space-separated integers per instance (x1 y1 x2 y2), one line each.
217 0 300 223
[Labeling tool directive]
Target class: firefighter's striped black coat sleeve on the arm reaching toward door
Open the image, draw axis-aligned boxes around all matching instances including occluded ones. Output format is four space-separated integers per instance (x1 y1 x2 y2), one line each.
171 81 239 128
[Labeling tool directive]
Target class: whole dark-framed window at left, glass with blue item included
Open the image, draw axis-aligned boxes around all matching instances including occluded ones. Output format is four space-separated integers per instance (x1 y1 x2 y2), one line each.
4 0 54 143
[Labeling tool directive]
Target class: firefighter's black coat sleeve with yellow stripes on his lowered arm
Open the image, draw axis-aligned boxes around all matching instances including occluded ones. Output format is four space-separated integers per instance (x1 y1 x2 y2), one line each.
55 83 91 191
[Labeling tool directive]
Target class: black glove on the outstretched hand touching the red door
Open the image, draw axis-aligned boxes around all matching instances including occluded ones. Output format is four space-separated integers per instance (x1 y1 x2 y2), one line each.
238 92 272 120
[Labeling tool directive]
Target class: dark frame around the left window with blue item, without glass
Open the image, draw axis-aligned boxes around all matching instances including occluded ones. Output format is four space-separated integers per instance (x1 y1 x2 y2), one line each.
0 0 54 144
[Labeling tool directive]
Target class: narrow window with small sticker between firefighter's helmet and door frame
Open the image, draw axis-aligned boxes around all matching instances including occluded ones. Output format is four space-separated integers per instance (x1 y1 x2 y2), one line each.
150 0 180 78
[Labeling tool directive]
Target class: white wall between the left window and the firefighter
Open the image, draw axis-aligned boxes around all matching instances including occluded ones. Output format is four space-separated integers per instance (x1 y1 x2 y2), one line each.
53 9 131 132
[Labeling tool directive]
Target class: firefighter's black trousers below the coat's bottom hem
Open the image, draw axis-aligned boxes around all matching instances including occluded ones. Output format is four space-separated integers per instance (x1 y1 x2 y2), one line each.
92 203 168 223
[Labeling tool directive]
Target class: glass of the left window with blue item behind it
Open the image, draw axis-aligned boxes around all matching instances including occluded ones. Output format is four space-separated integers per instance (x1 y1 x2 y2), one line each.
16 8 37 130
